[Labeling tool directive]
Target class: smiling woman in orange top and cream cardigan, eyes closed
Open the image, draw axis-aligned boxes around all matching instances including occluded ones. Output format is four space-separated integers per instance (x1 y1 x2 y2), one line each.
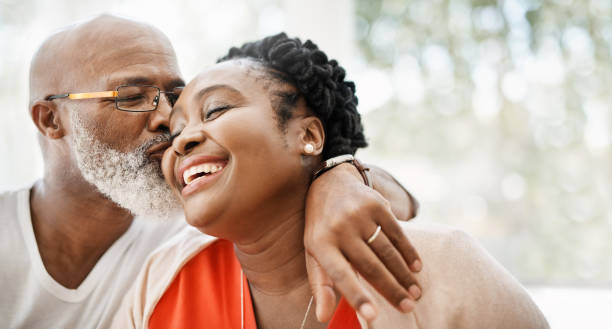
116 34 547 329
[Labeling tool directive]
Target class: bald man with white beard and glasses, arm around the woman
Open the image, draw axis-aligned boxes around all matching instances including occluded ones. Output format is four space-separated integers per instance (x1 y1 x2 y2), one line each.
0 16 421 328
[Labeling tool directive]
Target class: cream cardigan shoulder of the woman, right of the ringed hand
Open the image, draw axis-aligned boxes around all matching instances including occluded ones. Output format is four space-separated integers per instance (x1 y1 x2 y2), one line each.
360 221 548 329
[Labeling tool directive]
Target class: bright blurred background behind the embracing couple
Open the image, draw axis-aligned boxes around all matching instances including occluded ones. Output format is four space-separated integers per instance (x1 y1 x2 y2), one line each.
0 0 612 328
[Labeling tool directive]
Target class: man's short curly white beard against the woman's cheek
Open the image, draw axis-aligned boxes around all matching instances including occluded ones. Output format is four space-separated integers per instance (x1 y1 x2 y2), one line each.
71 109 181 219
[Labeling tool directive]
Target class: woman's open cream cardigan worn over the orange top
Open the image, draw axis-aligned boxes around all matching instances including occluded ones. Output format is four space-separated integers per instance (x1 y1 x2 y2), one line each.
112 221 549 329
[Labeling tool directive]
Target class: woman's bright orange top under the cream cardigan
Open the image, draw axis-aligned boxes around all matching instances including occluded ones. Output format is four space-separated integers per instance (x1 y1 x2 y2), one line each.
149 240 361 329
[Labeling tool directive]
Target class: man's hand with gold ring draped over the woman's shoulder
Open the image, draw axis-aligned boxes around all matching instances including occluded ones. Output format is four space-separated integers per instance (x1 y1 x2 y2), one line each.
304 163 422 322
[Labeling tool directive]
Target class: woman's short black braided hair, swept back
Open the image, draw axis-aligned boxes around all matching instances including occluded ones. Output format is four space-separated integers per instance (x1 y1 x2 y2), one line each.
217 33 367 160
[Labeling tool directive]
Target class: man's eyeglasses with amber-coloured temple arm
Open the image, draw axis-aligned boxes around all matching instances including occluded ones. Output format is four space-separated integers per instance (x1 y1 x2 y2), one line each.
45 85 183 112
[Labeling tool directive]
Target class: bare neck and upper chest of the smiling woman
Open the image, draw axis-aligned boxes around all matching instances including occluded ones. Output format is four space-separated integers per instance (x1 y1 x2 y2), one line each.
235 209 325 328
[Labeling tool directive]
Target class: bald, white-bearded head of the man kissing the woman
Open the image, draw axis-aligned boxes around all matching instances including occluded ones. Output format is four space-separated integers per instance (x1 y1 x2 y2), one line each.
30 15 185 215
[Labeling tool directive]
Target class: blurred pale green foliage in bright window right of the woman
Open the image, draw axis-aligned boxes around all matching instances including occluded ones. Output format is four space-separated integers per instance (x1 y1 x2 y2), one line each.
356 0 612 284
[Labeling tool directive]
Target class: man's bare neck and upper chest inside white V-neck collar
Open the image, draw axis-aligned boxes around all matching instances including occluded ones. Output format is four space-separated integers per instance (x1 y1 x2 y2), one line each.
30 177 133 289
